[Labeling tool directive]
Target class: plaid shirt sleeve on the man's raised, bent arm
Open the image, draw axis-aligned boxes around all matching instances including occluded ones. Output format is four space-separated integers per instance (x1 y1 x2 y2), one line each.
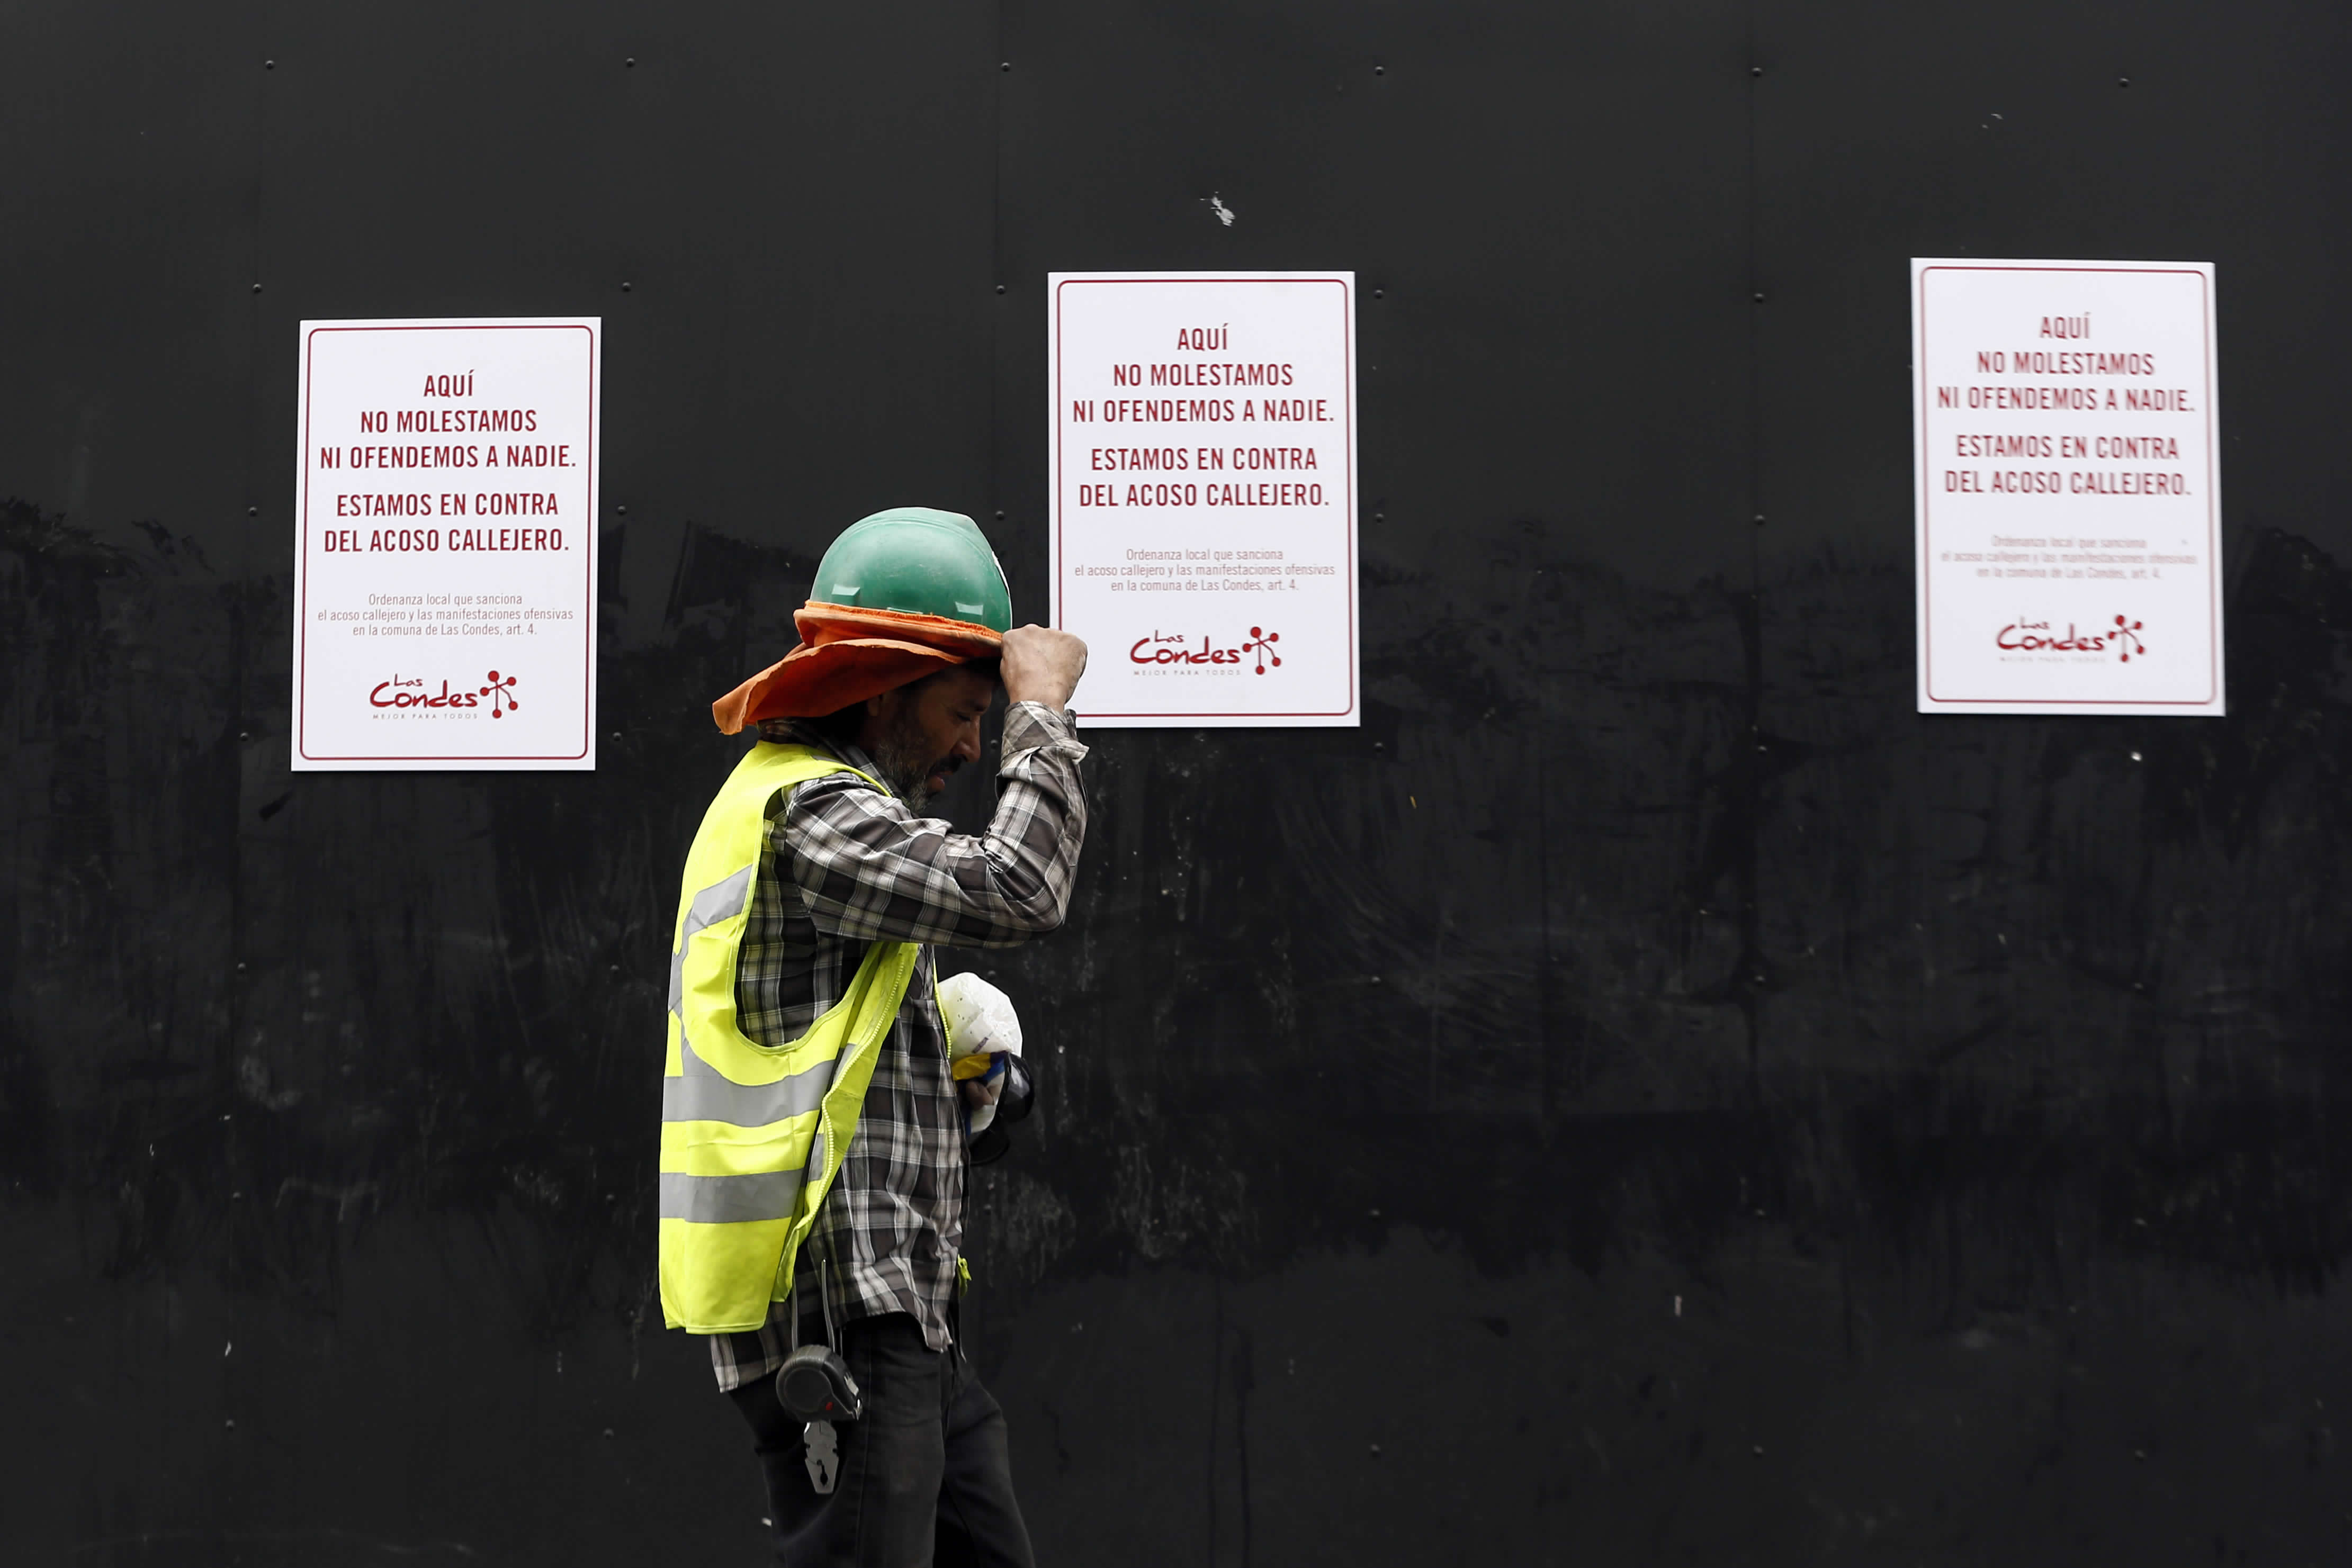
781 703 1087 948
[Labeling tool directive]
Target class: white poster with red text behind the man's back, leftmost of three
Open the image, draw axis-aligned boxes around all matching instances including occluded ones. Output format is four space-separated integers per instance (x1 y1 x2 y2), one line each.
294 318 605 771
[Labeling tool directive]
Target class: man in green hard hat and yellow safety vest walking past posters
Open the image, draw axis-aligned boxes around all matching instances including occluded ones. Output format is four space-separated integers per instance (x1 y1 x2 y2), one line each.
661 508 1087 1568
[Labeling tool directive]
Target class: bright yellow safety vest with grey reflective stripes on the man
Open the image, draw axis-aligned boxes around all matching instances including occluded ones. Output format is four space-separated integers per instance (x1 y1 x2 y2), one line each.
661 743 920 1333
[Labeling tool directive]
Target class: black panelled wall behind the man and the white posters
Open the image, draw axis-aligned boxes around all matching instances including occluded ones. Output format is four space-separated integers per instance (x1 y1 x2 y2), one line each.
0 0 2352 1566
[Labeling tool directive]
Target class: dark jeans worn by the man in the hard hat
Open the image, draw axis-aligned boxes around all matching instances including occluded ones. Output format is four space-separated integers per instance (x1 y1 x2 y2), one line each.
729 1312 1037 1568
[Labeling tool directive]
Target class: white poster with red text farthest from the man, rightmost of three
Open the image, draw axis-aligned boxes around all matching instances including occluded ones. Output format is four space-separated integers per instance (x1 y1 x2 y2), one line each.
1912 261 2223 715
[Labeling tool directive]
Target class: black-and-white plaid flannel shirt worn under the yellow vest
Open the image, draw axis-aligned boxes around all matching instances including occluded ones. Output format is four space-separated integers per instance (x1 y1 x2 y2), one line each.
710 703 1087 1390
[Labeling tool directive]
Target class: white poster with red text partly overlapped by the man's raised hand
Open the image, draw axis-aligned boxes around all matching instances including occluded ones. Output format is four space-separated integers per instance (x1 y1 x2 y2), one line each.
1047 273 1359 729
